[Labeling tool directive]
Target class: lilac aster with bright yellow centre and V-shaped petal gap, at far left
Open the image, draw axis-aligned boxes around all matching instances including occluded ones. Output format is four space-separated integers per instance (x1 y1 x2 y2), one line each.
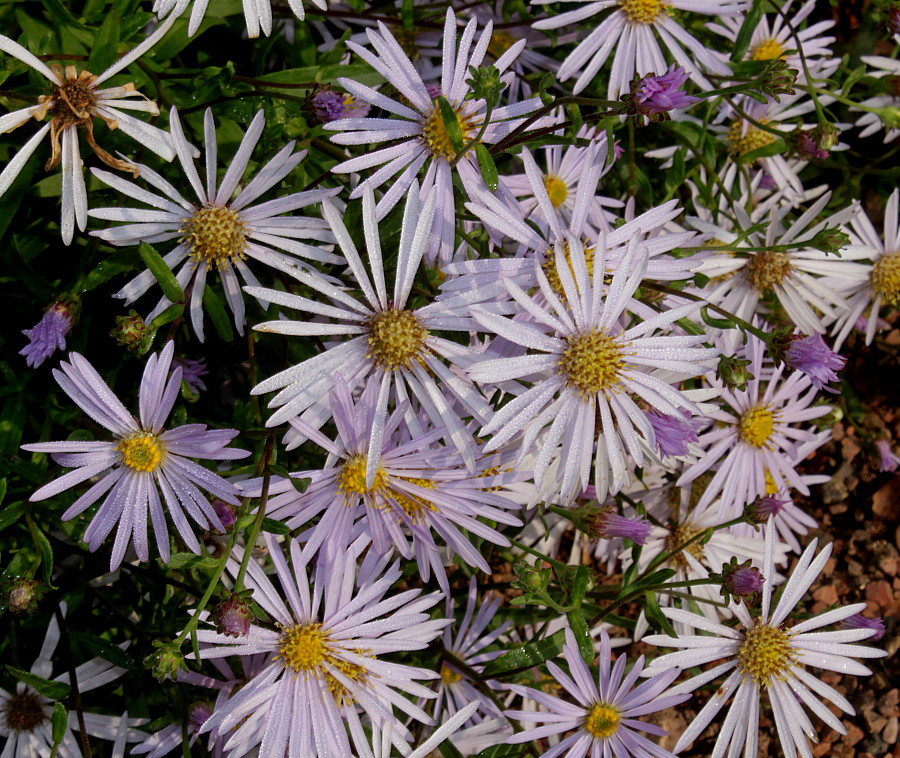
22 342 249 571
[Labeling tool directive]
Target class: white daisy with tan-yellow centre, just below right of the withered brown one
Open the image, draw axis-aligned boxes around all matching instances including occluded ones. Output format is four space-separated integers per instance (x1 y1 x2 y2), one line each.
88 108 344 342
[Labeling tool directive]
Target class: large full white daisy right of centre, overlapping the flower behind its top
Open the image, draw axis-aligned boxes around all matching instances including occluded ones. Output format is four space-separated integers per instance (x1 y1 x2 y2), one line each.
469 236 716 503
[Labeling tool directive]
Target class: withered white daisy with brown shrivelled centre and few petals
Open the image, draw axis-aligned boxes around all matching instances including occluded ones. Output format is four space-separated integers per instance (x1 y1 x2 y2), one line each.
0 13 178 245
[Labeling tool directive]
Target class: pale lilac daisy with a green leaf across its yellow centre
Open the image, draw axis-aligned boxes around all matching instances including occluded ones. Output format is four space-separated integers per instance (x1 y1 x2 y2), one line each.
325 8 543 262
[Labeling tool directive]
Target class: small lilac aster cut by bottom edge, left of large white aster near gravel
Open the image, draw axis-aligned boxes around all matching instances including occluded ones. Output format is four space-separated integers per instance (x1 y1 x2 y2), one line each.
506 627 690 758
